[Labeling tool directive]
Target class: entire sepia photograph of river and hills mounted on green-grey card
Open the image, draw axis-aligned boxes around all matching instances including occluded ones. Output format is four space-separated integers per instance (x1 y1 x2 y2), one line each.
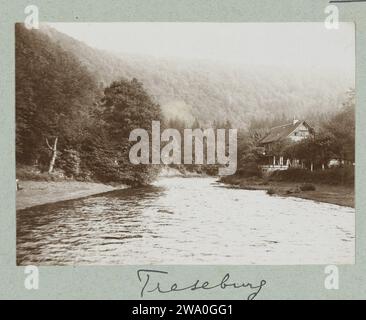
14 22 357 266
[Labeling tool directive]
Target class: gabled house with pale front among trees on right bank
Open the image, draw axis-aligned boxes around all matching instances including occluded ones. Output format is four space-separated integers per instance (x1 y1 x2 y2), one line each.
259 119 314 172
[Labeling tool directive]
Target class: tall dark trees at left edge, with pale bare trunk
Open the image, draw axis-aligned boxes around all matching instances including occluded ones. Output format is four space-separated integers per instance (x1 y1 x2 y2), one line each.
16 24 98 172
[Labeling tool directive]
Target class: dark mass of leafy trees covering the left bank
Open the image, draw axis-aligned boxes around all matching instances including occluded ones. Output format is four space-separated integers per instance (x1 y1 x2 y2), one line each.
16 24 161 184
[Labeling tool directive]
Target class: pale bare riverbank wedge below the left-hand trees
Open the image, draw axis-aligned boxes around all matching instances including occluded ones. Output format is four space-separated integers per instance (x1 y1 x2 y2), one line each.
16 181 127 210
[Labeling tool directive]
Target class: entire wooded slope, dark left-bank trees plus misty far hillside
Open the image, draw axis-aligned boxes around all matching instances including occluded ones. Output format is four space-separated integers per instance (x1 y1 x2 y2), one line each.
16 24 354 184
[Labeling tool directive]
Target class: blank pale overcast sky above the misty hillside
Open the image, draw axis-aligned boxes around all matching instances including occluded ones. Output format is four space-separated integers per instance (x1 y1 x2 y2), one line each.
49 22 355 73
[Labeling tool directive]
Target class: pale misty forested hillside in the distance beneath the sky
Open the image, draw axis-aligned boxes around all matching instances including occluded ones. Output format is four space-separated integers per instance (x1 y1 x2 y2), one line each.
43 26 354 128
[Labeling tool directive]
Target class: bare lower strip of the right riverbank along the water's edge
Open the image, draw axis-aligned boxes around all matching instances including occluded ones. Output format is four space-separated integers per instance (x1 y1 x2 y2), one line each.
220 176 355 208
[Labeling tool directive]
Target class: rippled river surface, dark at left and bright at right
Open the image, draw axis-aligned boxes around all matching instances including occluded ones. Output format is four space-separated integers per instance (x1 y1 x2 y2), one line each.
17 178 355 265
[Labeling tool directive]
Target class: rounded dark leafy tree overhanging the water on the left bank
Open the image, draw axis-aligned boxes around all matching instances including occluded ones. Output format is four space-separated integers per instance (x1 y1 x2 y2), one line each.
101 78 162 184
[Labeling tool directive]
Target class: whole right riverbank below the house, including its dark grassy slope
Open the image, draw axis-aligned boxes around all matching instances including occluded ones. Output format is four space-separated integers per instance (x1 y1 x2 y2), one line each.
220 166 355 208
